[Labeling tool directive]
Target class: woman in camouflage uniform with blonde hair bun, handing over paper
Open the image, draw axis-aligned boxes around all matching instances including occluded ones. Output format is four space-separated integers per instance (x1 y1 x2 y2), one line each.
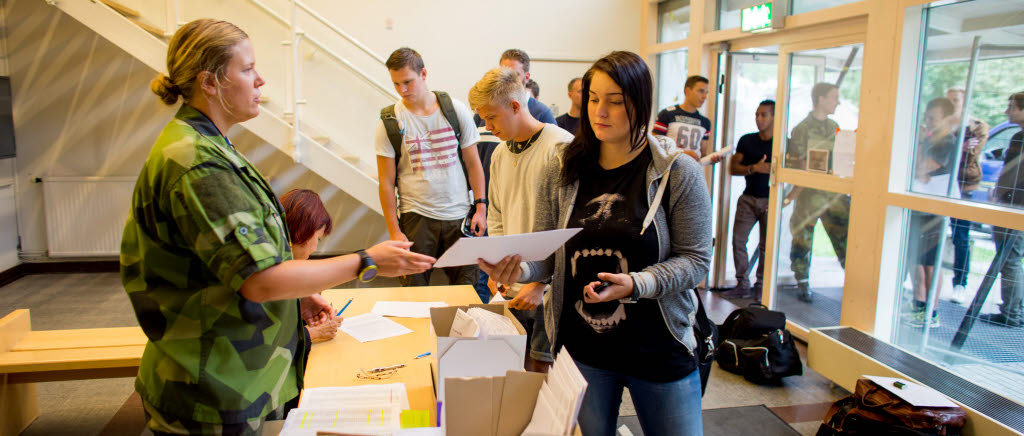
121 19 434 435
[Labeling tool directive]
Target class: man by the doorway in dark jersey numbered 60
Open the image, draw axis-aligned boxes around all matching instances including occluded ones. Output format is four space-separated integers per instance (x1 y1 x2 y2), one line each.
651 76 724 164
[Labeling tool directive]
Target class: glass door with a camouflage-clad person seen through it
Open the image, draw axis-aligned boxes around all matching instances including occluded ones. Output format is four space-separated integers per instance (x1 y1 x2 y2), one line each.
766 38 863 329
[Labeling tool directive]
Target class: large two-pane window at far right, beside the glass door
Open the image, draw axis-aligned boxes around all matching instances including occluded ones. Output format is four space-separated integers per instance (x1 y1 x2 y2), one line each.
879 0 1024 402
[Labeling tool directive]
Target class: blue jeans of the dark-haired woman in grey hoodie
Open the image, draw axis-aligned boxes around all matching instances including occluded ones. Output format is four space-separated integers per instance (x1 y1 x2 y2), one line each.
575 360 703 436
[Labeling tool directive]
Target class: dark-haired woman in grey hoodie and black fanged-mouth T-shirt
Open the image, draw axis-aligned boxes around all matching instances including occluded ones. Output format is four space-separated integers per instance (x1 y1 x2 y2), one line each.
479 51 712 436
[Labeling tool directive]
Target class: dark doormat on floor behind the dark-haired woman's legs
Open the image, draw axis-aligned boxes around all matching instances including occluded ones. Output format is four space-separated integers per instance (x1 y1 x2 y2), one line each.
615 404 800 436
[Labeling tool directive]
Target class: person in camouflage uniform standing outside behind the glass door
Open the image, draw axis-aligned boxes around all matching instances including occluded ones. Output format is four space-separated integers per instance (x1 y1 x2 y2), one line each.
782 83 850 303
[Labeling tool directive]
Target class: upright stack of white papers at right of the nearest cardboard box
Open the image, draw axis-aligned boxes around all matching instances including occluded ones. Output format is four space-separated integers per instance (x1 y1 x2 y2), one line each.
524 348 587 435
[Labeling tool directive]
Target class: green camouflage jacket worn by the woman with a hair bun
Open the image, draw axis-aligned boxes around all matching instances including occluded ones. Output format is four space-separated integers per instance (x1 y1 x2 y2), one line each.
121 104 308 424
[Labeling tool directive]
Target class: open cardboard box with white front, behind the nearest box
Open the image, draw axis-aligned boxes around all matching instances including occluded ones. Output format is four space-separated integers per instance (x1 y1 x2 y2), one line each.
430 304 526 406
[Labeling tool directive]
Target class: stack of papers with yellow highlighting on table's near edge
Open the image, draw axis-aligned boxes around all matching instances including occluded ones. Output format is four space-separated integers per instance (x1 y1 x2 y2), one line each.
281 383 409 436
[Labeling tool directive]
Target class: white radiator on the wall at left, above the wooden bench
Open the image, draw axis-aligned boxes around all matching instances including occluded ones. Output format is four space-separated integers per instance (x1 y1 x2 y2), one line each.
43 177 135 257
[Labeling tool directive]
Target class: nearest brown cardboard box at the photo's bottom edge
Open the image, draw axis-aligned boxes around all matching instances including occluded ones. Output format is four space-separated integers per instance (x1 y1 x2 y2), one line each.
444 370 579 436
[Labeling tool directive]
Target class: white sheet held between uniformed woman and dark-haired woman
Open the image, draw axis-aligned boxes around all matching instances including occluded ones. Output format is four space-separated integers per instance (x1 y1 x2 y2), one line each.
432 228 582 268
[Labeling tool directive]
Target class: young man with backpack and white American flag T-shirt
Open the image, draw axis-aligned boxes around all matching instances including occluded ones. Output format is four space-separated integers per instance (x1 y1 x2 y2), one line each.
375 47 487 286
